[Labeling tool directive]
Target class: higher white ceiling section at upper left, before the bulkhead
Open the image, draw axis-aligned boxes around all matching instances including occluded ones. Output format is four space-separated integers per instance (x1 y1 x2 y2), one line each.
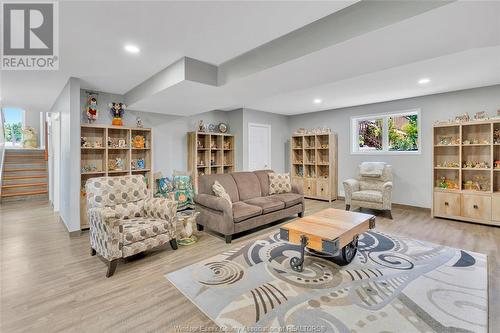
0 1 354 111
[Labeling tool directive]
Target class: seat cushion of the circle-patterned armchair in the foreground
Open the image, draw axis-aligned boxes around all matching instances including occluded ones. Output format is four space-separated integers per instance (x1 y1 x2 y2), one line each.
121 217 173 245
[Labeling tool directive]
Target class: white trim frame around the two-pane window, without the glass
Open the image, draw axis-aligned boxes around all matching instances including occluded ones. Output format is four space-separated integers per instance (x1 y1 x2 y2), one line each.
350 109 422 155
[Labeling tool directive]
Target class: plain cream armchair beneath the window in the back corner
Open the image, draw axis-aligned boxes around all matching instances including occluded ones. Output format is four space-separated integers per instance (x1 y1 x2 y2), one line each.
344 162 392 219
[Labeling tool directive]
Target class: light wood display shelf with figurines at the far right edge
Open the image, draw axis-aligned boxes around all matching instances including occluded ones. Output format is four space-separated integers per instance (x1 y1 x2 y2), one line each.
432 118 500 226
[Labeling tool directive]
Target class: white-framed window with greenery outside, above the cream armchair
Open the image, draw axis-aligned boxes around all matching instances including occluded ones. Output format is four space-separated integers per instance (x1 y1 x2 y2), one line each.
351 110 420 154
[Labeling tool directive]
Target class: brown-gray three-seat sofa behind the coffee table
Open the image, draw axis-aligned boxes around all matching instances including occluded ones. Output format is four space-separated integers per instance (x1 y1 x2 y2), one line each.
194 170 305 243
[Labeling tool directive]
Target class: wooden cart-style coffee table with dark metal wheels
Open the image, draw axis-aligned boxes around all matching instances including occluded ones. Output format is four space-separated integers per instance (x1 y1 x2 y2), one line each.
280 208 375 272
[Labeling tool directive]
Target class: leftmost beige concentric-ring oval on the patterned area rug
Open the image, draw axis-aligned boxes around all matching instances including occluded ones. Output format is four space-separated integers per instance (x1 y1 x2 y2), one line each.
193 260 244 287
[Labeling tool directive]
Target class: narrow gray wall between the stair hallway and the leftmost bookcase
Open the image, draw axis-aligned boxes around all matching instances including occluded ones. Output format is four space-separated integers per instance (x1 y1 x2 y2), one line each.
50 78 80 232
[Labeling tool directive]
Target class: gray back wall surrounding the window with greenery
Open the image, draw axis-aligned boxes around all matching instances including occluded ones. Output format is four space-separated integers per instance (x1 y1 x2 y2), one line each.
289 85 500 207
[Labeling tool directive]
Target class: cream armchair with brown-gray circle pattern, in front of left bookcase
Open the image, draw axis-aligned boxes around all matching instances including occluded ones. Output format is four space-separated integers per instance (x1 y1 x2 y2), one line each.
85 175 177 277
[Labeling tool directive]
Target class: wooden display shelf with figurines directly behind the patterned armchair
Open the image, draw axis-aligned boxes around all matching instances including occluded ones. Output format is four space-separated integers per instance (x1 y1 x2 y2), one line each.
80 124 153 229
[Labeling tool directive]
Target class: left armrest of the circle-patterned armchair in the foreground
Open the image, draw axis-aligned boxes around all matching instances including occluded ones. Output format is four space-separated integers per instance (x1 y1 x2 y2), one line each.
87 207 122 261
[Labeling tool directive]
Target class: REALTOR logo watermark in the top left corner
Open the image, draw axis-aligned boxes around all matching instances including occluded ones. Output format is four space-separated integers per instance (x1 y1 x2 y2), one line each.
1 2 59 70
